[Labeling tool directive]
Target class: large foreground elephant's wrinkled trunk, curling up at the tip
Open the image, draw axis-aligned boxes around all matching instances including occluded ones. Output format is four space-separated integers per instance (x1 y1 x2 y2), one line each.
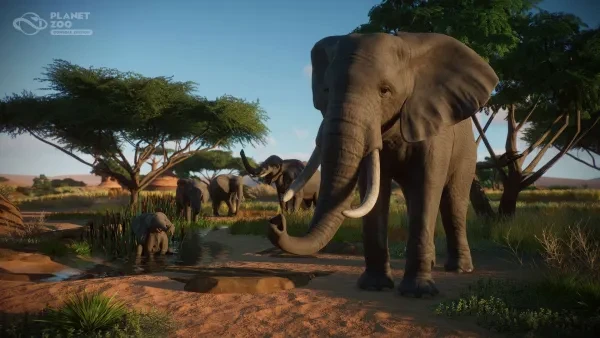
269 109 381 255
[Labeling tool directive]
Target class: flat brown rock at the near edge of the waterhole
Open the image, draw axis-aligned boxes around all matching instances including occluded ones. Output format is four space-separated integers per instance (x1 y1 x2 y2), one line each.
183 276 295 294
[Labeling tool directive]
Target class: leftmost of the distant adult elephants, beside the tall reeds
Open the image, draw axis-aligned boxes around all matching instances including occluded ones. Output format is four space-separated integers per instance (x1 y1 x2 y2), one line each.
175 178 210 222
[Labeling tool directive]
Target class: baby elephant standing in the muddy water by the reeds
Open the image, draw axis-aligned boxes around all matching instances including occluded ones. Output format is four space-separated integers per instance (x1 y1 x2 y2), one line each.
131 212 175 256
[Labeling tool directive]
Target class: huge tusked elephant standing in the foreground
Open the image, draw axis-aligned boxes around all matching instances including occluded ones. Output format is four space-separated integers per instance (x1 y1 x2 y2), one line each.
269 32 498 297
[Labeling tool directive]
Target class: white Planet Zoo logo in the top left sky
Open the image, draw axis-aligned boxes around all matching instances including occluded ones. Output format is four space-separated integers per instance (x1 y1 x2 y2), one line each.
13 12 93 35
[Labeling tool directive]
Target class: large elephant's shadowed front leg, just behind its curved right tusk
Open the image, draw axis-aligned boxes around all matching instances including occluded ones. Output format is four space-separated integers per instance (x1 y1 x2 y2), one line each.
357 158 394 291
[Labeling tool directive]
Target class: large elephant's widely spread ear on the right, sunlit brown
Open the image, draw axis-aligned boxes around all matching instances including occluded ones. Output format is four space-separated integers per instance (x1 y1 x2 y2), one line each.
396 32 498 142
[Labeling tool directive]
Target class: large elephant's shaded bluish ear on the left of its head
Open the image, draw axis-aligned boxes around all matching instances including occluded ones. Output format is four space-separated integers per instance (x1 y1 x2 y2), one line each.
310 35 345 115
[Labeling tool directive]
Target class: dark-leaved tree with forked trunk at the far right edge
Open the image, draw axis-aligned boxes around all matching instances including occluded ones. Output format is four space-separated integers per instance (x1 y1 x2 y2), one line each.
476 11 600 216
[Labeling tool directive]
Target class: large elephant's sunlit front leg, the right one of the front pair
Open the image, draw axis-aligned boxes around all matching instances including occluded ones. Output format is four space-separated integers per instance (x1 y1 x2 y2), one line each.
398 177 443 298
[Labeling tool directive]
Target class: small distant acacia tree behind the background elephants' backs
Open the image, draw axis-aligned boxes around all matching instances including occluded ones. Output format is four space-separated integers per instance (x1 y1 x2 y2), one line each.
174 150 256 181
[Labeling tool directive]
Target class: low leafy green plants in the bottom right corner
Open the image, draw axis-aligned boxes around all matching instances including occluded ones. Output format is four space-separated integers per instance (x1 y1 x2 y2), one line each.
435 279 600 337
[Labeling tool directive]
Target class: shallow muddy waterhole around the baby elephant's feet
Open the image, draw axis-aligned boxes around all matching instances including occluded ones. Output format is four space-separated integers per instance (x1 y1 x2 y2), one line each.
41 229 231 282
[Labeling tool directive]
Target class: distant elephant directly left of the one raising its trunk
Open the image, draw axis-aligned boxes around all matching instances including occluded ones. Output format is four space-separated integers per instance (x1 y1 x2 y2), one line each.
208 174 244 216
